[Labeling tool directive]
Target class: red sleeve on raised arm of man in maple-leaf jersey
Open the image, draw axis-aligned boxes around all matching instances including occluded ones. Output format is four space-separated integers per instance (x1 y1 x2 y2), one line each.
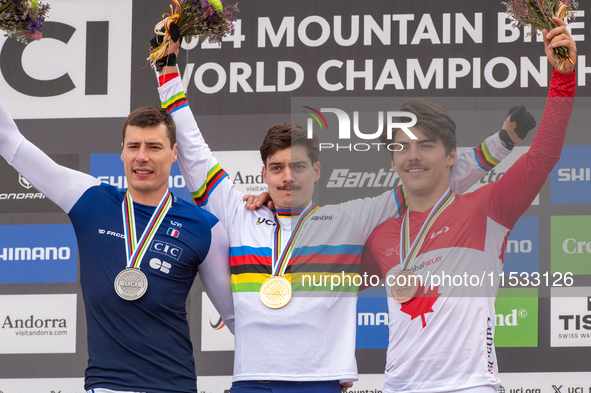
471 70 576 228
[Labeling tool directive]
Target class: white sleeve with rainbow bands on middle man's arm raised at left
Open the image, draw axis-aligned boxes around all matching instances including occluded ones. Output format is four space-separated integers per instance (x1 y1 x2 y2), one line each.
158 77 246 232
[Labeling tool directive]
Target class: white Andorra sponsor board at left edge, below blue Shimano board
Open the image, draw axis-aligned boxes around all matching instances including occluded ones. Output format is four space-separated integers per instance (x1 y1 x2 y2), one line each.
0 294 76 354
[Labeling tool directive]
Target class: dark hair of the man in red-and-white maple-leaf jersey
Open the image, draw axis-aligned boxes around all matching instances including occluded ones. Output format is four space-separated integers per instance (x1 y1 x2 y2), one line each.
380 100 457 155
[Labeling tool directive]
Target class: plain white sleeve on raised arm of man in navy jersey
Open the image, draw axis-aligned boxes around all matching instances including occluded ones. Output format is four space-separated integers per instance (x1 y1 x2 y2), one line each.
0 97 100 213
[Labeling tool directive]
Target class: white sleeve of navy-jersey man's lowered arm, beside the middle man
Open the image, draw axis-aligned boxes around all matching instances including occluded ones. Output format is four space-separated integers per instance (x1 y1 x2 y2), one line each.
199 222 234 334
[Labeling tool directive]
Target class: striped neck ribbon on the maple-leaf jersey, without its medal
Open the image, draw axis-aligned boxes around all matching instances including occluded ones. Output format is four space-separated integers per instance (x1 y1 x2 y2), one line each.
400 187 455 270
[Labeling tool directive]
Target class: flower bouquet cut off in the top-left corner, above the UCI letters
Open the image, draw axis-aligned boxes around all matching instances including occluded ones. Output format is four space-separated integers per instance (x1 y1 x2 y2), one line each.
0 0 49 44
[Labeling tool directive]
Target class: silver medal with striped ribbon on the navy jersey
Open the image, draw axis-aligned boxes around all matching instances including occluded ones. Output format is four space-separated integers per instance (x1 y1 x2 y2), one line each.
115 190 172 301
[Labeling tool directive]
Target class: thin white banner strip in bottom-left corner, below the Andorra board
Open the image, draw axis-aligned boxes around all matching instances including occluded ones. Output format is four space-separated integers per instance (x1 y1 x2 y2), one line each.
0 378 86 393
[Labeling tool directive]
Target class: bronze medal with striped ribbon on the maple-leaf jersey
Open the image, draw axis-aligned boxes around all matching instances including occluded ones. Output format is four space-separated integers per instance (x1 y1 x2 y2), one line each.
390 187 455 303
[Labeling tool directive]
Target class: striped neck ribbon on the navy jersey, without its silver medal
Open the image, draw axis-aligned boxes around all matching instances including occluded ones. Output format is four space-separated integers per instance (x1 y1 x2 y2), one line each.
121 190 172 269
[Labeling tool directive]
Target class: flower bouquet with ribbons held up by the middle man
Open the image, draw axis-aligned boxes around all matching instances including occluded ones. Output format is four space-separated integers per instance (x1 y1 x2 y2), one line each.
148 0 238 66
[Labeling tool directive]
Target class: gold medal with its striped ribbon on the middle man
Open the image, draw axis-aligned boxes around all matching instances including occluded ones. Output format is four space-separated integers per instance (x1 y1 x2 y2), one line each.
259 203 318 308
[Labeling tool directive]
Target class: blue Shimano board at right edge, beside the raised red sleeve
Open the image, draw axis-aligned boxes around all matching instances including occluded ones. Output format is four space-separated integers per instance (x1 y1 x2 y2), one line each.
551 145 591 205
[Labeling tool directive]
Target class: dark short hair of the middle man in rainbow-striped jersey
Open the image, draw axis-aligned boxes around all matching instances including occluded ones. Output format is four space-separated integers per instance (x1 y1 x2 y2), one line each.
260 123 320 166
